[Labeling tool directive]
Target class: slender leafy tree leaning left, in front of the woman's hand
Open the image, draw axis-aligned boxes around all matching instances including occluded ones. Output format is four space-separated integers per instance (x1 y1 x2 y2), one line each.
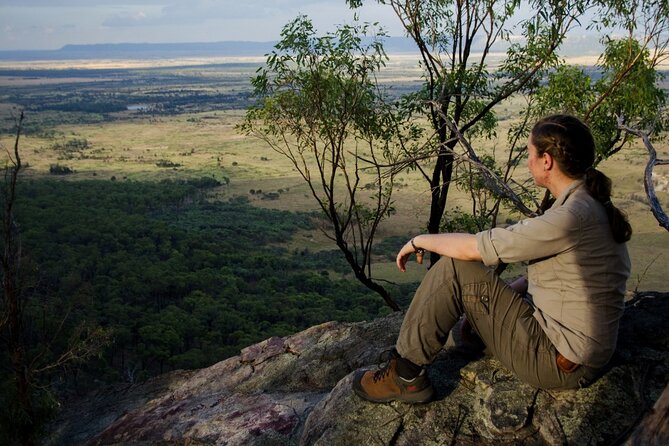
242 16 411 310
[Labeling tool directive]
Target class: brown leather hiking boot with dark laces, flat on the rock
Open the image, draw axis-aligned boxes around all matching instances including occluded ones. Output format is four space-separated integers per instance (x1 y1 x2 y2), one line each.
353 350 434 403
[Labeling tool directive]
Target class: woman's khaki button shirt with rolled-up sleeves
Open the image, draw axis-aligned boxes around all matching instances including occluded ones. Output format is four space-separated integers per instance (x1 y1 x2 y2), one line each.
476 180 630 367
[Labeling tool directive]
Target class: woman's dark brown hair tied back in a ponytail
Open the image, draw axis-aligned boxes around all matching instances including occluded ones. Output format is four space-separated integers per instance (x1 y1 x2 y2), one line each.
531 115 632 243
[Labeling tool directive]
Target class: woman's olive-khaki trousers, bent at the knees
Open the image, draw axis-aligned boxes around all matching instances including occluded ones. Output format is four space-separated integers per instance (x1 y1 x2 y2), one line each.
396 257 597 389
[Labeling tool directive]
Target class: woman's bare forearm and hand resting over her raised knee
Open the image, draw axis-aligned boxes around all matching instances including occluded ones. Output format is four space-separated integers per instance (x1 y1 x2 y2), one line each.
396 233 481 272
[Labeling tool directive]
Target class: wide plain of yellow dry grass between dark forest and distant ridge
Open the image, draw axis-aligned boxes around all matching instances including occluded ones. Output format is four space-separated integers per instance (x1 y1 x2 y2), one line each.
0 58 669 291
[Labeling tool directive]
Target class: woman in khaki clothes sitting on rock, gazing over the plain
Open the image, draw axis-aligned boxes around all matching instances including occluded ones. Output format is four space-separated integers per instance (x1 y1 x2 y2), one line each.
353 115 632 403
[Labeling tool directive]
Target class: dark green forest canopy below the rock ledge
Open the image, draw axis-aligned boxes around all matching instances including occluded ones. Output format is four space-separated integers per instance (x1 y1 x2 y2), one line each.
3 178 412 382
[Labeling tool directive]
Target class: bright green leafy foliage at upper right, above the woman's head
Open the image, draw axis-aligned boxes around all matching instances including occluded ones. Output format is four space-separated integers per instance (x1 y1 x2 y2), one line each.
534 0 669 162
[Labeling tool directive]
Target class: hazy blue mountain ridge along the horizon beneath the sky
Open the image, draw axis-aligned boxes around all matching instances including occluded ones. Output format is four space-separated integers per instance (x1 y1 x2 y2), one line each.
0 37 416 61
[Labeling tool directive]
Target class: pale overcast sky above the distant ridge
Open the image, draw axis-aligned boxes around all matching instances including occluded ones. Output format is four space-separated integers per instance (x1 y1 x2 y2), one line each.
0 0 402 50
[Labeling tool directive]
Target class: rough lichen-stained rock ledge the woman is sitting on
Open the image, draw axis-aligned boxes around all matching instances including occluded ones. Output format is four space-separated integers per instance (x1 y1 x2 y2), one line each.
48 293 669 446
